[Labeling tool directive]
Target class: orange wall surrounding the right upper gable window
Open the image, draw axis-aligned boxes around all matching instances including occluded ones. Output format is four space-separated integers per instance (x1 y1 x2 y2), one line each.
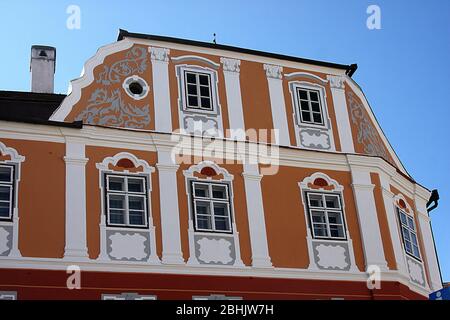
283 67 342 151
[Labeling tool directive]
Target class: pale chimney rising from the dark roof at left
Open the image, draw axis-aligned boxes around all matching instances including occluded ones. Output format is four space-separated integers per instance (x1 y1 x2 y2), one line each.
30 45 56 93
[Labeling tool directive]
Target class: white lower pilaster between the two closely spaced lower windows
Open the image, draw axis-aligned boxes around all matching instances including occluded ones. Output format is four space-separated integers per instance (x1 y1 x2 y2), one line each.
156 147 184 264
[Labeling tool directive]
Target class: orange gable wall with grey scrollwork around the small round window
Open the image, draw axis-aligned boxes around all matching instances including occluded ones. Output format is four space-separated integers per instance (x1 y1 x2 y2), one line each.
65 45 155 130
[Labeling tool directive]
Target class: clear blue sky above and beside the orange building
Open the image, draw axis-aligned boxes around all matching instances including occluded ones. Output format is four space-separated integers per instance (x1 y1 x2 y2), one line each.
0 0 450 281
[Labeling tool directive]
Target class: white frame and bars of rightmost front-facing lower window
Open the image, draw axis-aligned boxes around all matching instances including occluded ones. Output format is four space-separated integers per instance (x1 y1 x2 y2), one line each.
305 191 347 241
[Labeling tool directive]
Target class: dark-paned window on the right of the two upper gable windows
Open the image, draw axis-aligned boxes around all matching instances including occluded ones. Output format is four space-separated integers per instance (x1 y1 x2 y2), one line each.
297 88 324 125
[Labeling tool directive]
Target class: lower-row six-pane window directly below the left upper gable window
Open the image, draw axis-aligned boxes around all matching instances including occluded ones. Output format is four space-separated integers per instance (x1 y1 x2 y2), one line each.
192 182 232 232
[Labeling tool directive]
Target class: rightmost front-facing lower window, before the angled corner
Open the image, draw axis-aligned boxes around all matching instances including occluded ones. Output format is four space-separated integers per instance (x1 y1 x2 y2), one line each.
306 192 346 240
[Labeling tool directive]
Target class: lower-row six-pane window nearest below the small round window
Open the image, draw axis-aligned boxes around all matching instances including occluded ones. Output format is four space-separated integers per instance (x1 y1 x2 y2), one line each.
106 174 148 227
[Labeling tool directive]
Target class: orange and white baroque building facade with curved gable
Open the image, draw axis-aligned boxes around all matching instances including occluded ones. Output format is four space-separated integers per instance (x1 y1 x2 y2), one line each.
0 30 442 300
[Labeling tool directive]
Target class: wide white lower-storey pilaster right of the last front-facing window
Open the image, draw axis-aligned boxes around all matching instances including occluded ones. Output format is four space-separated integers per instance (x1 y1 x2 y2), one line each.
347 156 388 271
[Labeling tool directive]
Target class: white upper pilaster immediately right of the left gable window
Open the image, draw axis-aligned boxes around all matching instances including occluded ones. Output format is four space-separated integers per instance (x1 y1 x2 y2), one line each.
220 58 245 140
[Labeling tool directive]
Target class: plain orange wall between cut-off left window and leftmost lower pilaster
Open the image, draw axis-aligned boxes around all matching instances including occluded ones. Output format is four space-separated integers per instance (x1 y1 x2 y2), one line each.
0 138 66 258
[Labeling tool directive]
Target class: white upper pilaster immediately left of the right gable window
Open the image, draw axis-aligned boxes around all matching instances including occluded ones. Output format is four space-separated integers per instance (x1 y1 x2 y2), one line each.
264 64 291 146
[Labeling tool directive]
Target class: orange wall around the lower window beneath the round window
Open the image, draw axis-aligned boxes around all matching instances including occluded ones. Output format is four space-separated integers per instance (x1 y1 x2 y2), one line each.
86 146 162 259
